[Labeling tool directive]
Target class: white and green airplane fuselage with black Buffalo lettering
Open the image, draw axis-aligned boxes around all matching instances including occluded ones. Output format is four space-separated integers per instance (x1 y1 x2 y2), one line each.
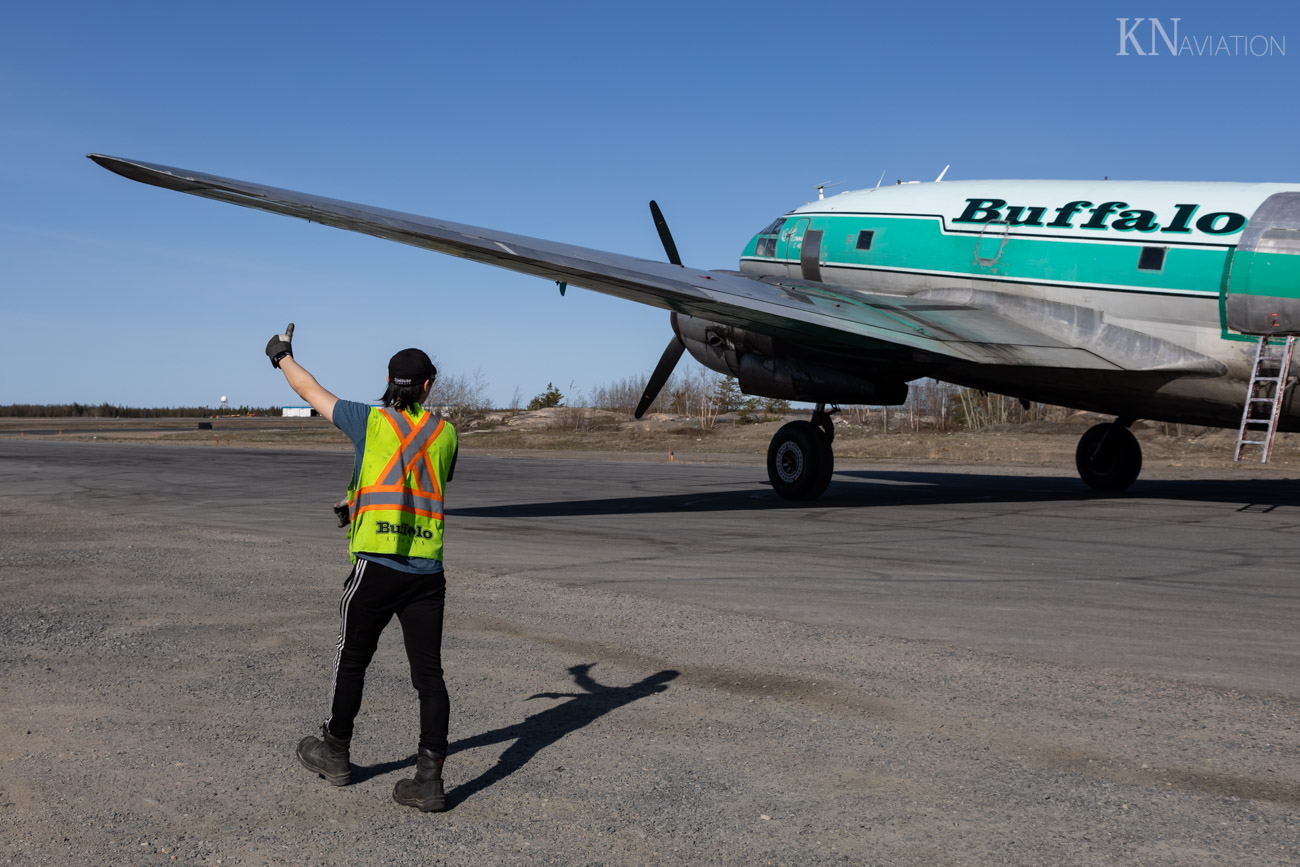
740 181 1300 428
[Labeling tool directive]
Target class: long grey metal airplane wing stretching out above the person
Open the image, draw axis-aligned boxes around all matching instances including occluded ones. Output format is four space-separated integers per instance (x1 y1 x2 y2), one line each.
88 153 1221 373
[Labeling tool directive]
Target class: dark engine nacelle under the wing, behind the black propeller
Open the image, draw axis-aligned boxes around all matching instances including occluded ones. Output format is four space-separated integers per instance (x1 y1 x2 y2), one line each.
672 315 907 406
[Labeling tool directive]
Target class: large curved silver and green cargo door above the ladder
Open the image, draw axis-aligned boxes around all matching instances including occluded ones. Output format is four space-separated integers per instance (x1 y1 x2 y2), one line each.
1223 192 1300 334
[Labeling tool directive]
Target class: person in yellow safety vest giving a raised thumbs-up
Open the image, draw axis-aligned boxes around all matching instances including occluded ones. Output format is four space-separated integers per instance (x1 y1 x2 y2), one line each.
267 324 456 811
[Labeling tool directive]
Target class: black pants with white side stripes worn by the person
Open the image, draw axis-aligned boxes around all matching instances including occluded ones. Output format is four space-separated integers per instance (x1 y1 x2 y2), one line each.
325 559 449 754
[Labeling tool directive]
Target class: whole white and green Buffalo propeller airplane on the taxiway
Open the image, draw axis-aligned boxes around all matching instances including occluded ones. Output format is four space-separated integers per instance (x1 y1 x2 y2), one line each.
87 153 1300 500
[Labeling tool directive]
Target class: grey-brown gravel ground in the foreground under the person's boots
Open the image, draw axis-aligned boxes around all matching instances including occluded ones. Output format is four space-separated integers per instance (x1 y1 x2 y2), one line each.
0 498 1300 864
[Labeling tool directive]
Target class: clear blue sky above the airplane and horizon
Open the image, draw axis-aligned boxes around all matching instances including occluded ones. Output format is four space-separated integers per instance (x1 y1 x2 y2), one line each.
0 0 1300 406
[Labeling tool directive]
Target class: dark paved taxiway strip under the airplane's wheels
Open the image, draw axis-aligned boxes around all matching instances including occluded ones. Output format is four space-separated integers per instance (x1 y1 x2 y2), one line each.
0 442 1300 698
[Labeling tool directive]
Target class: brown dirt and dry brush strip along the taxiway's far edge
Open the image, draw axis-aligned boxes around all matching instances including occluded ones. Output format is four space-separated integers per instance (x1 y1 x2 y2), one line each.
0 407 1300 473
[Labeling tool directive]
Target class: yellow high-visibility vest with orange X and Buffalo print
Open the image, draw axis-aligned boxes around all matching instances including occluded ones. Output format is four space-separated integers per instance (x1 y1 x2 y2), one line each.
347 407 456 563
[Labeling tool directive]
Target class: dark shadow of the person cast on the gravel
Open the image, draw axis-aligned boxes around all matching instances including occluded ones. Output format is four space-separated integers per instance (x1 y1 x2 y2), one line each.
447 663 680 810
